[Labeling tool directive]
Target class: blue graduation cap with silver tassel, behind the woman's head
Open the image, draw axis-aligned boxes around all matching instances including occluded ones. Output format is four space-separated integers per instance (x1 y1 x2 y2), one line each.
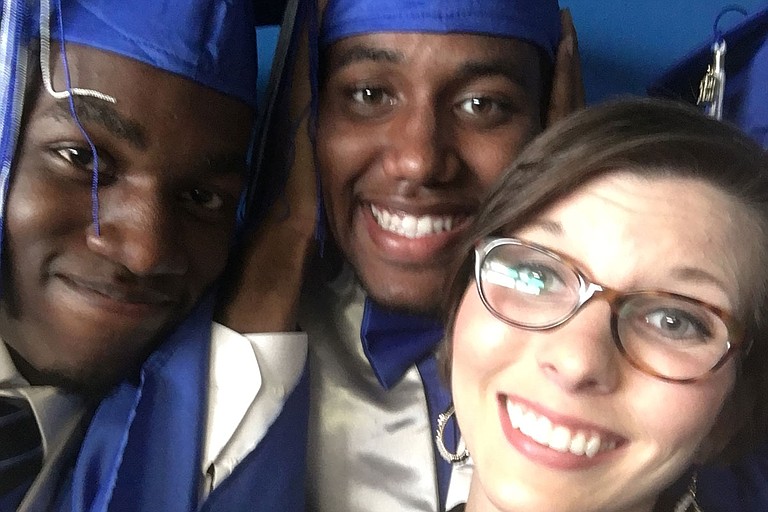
648 9 768 148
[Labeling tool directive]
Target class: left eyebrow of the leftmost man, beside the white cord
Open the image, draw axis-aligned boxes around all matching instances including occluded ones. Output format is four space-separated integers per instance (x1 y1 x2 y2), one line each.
51 96 147 149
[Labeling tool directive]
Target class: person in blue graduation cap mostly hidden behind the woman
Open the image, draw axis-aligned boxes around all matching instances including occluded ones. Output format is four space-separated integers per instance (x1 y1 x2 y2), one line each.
649 9 768 512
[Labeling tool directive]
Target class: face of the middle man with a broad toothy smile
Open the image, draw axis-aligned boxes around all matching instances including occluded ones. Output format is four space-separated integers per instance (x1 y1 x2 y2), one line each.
317 33 543 313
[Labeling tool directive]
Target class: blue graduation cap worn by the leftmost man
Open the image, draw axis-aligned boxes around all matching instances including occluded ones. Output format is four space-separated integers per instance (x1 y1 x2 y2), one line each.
38 0 257 107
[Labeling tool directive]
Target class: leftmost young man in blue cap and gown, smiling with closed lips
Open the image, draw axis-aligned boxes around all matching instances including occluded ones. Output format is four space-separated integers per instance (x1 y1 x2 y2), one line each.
0 0 307 511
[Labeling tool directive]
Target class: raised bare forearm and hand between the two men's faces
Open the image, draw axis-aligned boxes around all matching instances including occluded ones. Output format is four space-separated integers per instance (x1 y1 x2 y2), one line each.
216 0 317 333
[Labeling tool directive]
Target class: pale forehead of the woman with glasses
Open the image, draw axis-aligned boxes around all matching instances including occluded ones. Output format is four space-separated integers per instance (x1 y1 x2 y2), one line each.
521 172 764 309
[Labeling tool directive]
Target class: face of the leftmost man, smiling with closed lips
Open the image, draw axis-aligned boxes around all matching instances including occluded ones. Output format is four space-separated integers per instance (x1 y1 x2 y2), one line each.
0 44 253 393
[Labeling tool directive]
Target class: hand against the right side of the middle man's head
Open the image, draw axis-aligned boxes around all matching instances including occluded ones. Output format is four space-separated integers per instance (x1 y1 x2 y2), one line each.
545 9 585 126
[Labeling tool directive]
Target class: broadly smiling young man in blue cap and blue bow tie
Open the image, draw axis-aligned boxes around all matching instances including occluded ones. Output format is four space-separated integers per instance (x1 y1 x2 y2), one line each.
228 0 583 512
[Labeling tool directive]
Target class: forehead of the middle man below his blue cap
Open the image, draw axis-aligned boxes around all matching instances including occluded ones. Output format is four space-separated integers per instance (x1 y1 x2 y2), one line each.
326 32 541 87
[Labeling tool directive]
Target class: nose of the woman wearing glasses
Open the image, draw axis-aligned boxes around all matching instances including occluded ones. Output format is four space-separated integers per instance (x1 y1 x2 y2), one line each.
536 301 624 394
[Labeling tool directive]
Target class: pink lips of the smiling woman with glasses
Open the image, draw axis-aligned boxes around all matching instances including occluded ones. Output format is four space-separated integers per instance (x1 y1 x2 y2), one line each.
498 394 627 470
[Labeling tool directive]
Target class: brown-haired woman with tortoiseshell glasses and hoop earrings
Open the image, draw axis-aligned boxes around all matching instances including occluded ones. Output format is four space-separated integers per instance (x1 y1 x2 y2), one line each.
437 100 768 512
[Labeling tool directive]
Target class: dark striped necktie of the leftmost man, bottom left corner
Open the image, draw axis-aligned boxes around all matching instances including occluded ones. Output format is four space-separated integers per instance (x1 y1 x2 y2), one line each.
0 397 43 510
